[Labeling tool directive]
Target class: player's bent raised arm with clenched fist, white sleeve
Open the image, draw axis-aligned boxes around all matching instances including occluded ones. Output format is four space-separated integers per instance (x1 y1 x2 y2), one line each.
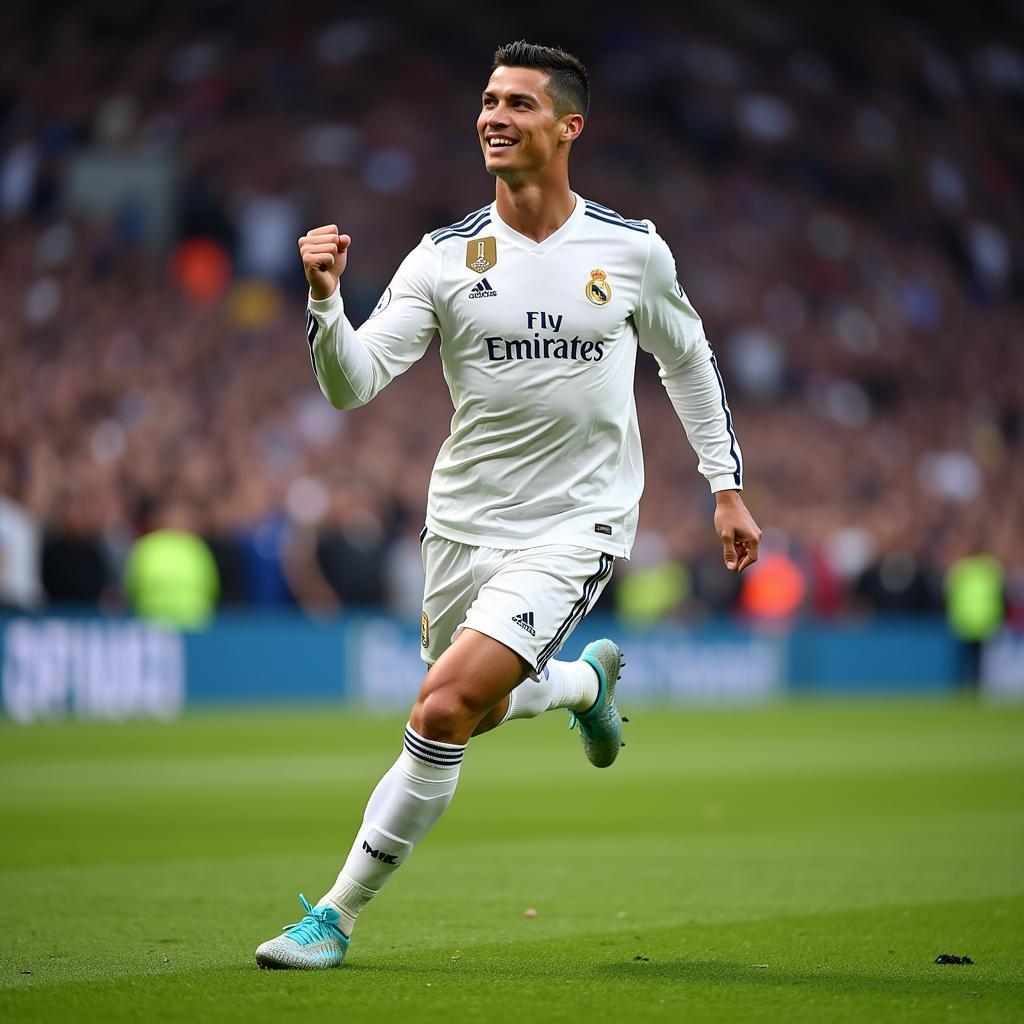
299 224 439 409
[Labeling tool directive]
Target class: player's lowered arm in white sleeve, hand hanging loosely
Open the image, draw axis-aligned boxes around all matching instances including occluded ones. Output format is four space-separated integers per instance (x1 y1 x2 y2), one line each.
633 231 761 572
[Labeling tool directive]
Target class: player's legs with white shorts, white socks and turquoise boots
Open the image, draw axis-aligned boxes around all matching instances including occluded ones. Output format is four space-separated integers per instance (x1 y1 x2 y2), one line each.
257 535 622 967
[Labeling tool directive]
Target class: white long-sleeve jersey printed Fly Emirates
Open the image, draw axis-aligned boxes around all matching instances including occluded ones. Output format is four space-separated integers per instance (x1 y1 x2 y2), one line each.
306 196 742 557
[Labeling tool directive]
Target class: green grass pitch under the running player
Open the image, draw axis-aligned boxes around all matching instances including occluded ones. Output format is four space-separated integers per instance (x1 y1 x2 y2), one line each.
0 698 1024 1024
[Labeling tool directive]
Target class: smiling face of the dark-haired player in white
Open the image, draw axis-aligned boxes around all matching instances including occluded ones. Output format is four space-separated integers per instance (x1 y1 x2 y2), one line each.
476 68 568 177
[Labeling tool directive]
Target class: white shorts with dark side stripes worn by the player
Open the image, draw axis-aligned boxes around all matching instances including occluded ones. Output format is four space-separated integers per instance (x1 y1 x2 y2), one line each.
420 530 614 675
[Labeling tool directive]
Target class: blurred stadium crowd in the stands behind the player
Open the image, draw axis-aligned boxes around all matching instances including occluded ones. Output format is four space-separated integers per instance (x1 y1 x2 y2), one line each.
0 0 1024 617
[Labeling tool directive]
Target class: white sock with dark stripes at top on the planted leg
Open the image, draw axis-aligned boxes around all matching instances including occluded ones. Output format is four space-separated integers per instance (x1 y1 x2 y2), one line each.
316 725 466 935
